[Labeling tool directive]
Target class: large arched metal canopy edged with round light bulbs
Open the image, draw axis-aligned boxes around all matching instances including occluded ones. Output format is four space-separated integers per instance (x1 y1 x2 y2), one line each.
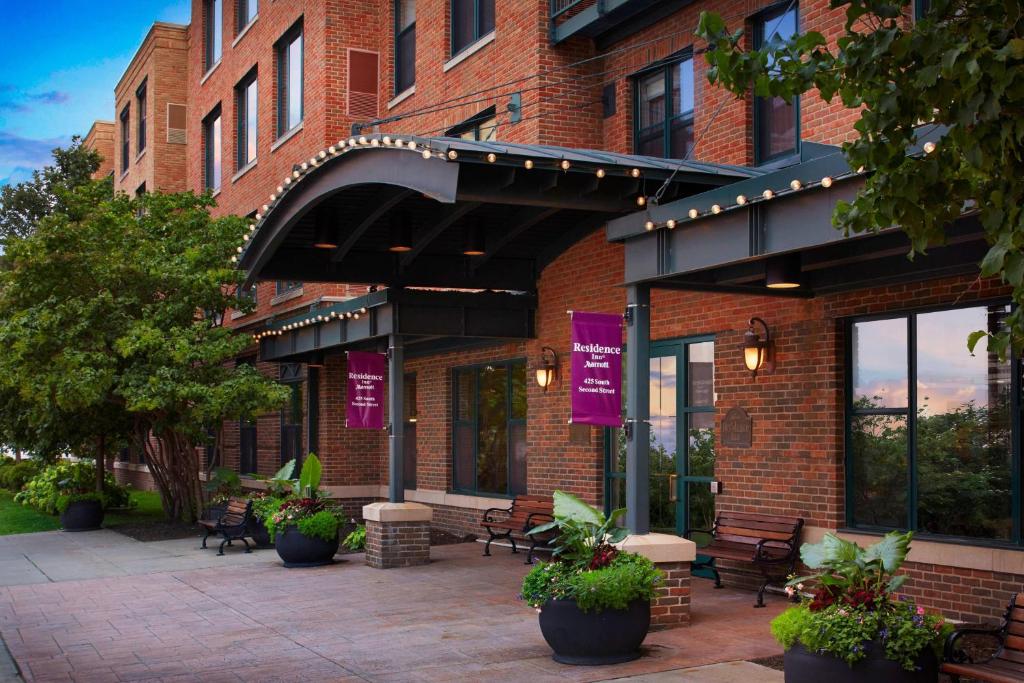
240 135 757 291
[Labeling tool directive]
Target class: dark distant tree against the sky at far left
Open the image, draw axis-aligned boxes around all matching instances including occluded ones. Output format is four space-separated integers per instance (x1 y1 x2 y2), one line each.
0 135 107 244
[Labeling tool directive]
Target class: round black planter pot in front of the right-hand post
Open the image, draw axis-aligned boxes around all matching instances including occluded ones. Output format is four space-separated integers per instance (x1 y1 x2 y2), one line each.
541 600 650 666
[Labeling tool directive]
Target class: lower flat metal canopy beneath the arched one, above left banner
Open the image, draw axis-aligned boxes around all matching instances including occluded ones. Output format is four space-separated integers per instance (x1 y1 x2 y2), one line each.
259 289 537 362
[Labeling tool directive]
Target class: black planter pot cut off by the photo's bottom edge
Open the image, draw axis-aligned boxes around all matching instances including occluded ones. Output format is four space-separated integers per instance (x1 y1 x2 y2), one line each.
783 640 939 683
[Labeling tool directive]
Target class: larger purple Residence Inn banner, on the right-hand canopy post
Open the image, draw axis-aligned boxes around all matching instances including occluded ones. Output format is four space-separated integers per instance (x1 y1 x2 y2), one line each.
569 311 623 427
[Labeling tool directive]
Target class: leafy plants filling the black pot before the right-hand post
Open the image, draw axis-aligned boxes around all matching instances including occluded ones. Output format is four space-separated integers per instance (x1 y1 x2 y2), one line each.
522 490 663 612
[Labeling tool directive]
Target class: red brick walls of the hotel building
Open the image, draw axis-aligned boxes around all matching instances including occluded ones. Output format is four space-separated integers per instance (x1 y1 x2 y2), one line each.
81 0 1024 618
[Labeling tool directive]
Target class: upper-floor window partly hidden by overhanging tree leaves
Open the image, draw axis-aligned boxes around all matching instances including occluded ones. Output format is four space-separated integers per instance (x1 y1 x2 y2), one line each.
754 4 800 164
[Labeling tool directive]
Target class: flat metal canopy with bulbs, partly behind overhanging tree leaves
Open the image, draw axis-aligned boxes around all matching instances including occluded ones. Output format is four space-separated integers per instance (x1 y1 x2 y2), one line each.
606 131 987 297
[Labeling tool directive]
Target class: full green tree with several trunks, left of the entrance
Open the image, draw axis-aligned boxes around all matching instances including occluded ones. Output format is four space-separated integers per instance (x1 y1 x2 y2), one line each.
0 181 286 521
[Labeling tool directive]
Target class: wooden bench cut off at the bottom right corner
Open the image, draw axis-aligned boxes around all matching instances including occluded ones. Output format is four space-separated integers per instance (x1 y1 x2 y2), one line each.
942 593 1024 683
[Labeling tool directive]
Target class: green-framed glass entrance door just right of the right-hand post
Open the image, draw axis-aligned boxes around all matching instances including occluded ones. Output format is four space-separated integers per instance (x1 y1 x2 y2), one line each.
650 337 715 541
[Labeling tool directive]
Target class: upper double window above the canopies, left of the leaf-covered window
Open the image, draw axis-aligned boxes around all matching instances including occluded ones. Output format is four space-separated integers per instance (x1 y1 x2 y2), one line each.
634 54 693 159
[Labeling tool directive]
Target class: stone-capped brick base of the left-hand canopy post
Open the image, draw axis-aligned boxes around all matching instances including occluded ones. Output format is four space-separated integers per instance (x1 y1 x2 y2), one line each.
362 503 433 569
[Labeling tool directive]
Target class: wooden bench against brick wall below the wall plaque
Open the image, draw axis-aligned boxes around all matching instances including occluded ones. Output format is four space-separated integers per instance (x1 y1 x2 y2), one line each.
685 512 804 607
